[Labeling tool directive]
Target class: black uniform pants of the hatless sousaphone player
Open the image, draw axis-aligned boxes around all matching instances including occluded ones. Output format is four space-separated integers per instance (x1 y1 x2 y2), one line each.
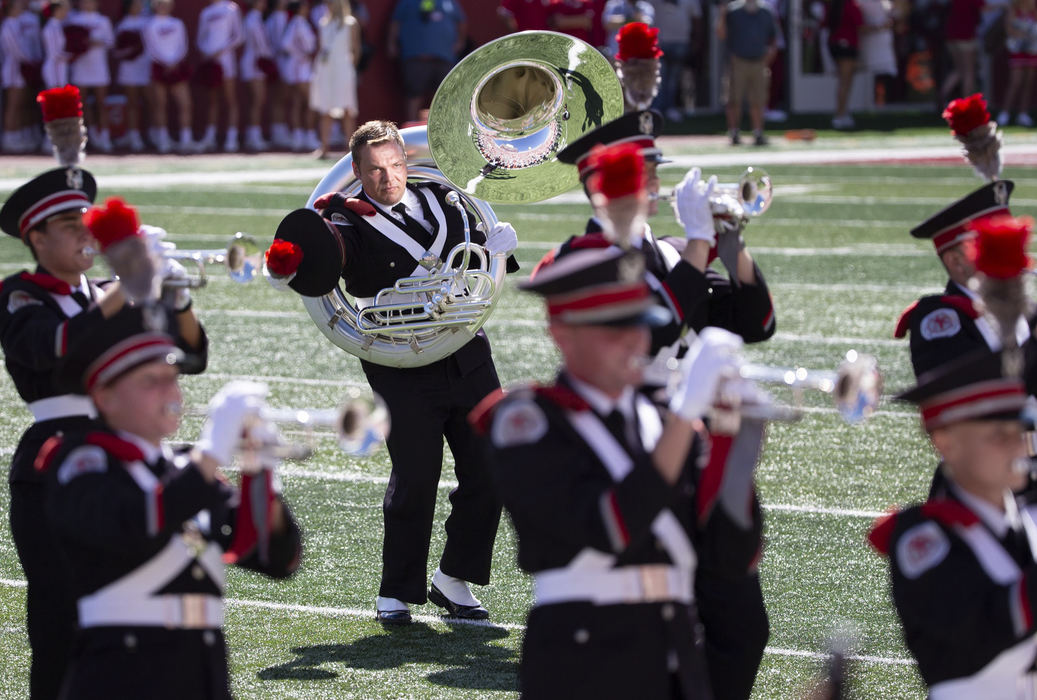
363 352 501 604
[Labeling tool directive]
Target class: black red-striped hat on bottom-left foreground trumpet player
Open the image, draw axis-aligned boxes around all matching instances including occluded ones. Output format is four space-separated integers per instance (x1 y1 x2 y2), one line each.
55 306 187 394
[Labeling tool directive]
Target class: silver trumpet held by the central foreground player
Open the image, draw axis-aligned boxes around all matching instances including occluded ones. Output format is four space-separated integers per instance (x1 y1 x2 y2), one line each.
720 349 882 424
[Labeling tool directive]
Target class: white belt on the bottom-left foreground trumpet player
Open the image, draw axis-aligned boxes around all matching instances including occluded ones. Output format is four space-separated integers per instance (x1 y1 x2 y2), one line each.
79 593 223 629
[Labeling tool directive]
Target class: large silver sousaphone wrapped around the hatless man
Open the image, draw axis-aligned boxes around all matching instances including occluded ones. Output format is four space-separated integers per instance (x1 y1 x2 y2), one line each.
303 32 623 367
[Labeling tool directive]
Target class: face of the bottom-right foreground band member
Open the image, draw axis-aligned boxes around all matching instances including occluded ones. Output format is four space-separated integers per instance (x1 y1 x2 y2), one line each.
932 420 1026 496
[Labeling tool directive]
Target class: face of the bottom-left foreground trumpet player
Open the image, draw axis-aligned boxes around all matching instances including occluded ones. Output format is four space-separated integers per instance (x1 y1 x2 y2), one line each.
90 361 183 445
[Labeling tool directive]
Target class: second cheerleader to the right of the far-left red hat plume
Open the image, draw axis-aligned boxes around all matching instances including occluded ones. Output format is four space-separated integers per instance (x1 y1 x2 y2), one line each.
112 0 151 153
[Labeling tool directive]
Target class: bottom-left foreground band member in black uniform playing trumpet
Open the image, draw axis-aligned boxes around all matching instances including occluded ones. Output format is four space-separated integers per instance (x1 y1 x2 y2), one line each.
37 307 302 700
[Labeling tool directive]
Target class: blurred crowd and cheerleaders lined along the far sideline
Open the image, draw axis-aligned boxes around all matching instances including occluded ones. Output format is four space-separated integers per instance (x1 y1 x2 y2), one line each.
0 0 1037 158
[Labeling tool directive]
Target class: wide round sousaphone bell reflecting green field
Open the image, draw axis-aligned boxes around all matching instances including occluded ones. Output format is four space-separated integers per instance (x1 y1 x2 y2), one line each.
428 31 623 203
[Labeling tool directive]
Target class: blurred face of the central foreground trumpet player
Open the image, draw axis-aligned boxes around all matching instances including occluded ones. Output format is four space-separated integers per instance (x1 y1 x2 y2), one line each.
550 324 651 396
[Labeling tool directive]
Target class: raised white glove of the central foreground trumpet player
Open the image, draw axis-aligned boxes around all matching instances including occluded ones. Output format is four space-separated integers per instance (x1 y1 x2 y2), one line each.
670 327 742 420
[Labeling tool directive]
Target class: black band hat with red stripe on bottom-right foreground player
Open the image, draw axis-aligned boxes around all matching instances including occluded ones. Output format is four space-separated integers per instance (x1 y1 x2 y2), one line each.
894 349 1027 432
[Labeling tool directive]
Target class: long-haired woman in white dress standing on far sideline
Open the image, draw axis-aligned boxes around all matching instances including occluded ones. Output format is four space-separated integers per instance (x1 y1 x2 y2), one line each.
310 0 360 159
